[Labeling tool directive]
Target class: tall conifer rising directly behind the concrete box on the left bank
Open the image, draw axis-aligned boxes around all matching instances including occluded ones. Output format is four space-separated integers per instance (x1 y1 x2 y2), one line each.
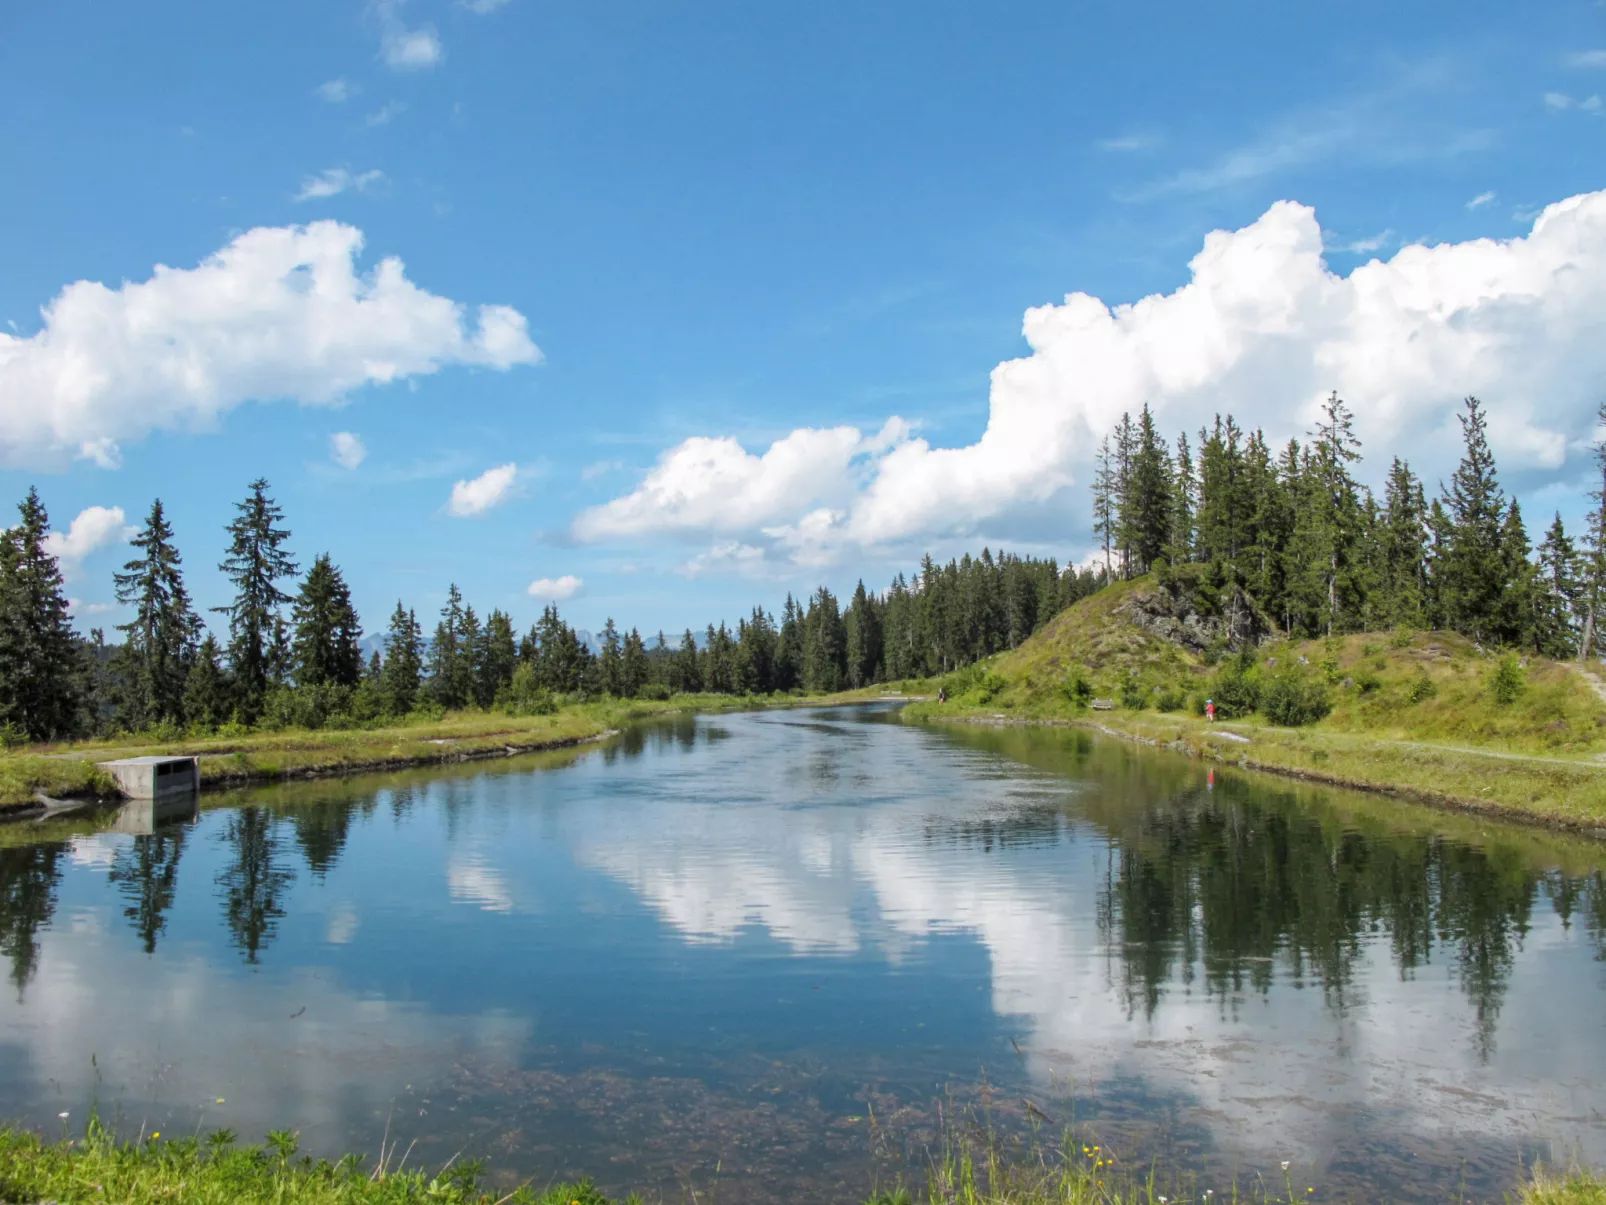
112 498 202 728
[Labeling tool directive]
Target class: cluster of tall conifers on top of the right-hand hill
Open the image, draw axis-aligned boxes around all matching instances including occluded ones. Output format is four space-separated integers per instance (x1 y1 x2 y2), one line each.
1094 394 1606 657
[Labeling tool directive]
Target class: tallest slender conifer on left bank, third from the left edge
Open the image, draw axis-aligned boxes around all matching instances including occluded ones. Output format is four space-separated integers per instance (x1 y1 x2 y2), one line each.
215 477 296 721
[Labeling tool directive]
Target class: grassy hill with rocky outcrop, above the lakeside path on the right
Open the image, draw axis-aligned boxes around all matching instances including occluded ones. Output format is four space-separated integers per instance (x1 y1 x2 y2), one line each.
944 577 1606 757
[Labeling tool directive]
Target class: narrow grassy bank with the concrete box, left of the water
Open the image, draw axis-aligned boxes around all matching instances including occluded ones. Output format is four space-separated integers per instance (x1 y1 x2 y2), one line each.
0 688 905 811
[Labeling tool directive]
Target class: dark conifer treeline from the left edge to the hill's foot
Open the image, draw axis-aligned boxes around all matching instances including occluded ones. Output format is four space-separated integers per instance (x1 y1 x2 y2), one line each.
0 480 1103 744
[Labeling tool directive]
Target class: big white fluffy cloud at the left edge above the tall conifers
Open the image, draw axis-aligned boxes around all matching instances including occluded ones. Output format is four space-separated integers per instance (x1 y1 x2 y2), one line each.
0 222 541 466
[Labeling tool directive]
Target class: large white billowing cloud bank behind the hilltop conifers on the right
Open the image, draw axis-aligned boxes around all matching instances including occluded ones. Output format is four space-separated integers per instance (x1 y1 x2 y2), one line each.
573 193 1606 562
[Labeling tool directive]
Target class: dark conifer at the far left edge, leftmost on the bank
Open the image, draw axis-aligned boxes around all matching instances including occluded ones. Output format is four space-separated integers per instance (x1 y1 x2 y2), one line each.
0 488 84 741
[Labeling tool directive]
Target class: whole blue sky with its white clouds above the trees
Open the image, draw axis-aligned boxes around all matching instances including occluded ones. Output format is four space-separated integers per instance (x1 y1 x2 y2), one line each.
0 0 1606 631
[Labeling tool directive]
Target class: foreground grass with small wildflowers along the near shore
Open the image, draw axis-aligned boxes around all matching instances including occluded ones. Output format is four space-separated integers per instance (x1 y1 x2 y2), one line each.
0 1121 1606 1205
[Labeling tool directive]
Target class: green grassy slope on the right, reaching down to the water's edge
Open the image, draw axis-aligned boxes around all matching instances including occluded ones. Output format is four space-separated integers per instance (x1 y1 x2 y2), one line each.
907 580 1606 829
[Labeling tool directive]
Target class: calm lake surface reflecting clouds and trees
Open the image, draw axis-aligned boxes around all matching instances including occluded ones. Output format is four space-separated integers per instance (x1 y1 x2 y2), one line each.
0 709 1606 1200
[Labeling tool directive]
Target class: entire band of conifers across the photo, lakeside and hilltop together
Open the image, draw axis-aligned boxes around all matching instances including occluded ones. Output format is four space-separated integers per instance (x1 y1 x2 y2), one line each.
0 394 1606 744
